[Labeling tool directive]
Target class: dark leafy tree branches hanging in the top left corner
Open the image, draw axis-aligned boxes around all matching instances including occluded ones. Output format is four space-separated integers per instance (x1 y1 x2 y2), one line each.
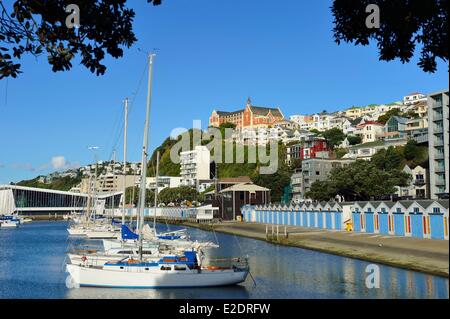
0 0 161 79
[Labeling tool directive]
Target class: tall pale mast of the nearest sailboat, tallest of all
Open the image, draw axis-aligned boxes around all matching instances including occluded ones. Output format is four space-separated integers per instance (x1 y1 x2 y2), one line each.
138 54 155 261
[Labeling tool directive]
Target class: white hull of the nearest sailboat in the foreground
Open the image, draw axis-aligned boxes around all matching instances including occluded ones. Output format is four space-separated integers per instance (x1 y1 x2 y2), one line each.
67 265 248 288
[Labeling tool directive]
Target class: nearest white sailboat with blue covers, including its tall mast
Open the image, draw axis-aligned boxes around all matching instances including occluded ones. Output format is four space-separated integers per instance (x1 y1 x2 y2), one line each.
67 54 249 288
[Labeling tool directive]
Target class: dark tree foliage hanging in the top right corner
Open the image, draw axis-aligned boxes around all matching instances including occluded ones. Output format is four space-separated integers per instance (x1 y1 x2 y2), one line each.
331 0 448 72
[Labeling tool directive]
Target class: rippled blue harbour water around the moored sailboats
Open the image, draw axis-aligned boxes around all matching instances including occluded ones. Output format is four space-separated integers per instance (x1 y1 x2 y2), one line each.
0 222 449 299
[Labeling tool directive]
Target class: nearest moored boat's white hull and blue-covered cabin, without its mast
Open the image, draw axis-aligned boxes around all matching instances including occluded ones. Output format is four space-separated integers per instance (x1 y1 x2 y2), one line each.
67 251 249 288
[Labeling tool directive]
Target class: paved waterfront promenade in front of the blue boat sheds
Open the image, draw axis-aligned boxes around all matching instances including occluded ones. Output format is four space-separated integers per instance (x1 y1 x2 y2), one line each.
183 222 449 277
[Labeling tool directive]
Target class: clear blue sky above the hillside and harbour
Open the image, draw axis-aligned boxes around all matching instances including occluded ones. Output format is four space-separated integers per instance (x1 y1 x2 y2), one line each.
0 0 448 183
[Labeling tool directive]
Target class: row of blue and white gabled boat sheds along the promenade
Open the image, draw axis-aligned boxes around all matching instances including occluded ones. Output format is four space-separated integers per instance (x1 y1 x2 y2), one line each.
241 200 449 240
